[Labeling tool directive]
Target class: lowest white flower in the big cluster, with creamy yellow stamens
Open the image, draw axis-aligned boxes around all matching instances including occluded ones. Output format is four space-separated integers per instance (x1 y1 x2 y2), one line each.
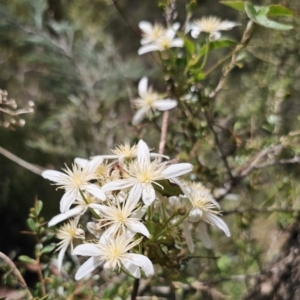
73 234 154 280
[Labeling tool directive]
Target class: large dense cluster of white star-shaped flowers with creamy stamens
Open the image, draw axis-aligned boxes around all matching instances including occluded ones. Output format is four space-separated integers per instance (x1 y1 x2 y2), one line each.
42 140 229 280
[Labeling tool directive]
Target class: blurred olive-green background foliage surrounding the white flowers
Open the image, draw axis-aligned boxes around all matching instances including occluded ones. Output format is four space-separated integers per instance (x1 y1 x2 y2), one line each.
0 0 300 299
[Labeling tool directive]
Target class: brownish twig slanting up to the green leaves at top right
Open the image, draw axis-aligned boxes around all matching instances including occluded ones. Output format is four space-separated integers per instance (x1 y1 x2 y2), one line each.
209 21 254 98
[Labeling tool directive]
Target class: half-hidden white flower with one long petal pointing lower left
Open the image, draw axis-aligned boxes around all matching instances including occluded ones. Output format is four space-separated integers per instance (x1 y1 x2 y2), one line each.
48 193 99 227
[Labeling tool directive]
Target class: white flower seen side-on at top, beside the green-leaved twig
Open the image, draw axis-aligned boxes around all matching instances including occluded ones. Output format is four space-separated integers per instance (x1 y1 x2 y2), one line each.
191 16 240 41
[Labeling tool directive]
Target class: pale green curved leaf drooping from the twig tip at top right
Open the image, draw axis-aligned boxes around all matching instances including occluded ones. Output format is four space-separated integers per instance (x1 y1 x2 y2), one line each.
245 1 293 30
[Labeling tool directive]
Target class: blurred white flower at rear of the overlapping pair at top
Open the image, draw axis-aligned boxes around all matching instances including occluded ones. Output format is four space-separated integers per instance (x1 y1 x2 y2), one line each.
139 21 180 45
